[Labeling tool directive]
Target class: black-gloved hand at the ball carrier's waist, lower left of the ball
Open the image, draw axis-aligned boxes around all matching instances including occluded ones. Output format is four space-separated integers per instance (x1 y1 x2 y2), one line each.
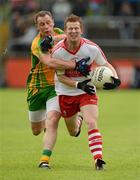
77 79 95 95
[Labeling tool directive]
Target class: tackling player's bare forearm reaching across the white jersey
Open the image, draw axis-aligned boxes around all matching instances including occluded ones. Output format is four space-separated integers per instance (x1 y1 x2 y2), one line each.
40 53 76 69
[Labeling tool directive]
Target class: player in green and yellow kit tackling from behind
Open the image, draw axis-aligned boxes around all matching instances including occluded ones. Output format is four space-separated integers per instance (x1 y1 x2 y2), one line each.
27 11 88 168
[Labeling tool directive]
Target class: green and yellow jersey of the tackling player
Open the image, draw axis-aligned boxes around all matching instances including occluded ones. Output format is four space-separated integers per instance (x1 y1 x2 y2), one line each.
27 28 64 91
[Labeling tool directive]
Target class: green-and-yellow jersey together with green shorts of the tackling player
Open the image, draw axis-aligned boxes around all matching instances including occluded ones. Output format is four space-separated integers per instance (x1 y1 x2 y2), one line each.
27 28 65 111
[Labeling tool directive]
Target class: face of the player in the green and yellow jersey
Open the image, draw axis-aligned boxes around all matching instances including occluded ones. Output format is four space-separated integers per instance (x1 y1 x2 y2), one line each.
37 15 54 37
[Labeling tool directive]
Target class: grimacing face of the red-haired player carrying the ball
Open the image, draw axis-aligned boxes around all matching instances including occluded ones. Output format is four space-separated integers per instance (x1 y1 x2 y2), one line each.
65 21 82 42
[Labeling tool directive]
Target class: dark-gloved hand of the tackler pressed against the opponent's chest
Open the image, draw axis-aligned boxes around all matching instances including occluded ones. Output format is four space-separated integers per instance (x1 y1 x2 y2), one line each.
75 57 90 76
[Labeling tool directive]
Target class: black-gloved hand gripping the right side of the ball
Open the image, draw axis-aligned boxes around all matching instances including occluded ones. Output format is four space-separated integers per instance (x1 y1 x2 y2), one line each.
103 76 121 90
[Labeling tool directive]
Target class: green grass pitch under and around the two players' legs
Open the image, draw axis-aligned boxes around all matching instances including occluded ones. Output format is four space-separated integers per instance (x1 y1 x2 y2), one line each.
0 89 140 180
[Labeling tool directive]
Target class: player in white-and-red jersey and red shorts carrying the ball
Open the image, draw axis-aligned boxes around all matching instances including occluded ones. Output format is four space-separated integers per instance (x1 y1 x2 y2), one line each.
52 15 118 170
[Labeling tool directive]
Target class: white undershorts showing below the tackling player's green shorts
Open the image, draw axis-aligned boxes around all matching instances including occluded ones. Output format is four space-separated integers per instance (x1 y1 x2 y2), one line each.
29 96 60 122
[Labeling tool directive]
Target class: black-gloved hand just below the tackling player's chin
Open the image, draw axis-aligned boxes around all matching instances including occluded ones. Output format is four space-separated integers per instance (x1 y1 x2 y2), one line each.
40 36 54 53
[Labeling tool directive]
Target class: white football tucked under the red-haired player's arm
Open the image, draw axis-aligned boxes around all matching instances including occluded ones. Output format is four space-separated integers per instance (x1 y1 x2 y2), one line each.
90 66 114 89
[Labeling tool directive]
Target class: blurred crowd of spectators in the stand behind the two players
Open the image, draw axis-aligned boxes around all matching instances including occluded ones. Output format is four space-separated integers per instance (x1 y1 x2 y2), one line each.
0 0 140 51
